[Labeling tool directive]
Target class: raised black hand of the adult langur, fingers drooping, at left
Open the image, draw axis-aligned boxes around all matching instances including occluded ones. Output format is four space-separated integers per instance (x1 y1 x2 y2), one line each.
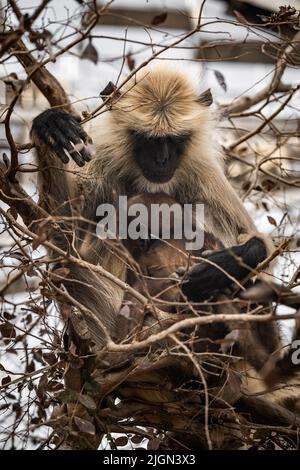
31 109 92 166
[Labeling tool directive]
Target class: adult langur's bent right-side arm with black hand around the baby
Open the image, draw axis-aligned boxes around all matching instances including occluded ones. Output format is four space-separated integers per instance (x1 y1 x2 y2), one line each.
182 166 272 301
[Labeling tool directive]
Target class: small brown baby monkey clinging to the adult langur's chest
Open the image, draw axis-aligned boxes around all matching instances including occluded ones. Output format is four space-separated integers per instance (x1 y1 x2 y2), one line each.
124 194 223 312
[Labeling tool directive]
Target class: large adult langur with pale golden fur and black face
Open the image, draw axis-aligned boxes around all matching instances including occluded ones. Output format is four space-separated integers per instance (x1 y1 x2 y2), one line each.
31 66 272 347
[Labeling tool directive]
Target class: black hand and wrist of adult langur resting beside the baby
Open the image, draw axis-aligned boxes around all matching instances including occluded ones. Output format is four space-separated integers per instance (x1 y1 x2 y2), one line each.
181 237 267 302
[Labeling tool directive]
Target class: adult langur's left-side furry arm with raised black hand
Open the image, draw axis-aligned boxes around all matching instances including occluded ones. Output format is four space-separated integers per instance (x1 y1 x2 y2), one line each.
31 109 126 347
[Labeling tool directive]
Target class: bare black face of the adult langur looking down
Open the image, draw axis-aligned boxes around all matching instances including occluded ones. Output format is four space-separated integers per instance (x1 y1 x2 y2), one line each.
130 131 190 183
